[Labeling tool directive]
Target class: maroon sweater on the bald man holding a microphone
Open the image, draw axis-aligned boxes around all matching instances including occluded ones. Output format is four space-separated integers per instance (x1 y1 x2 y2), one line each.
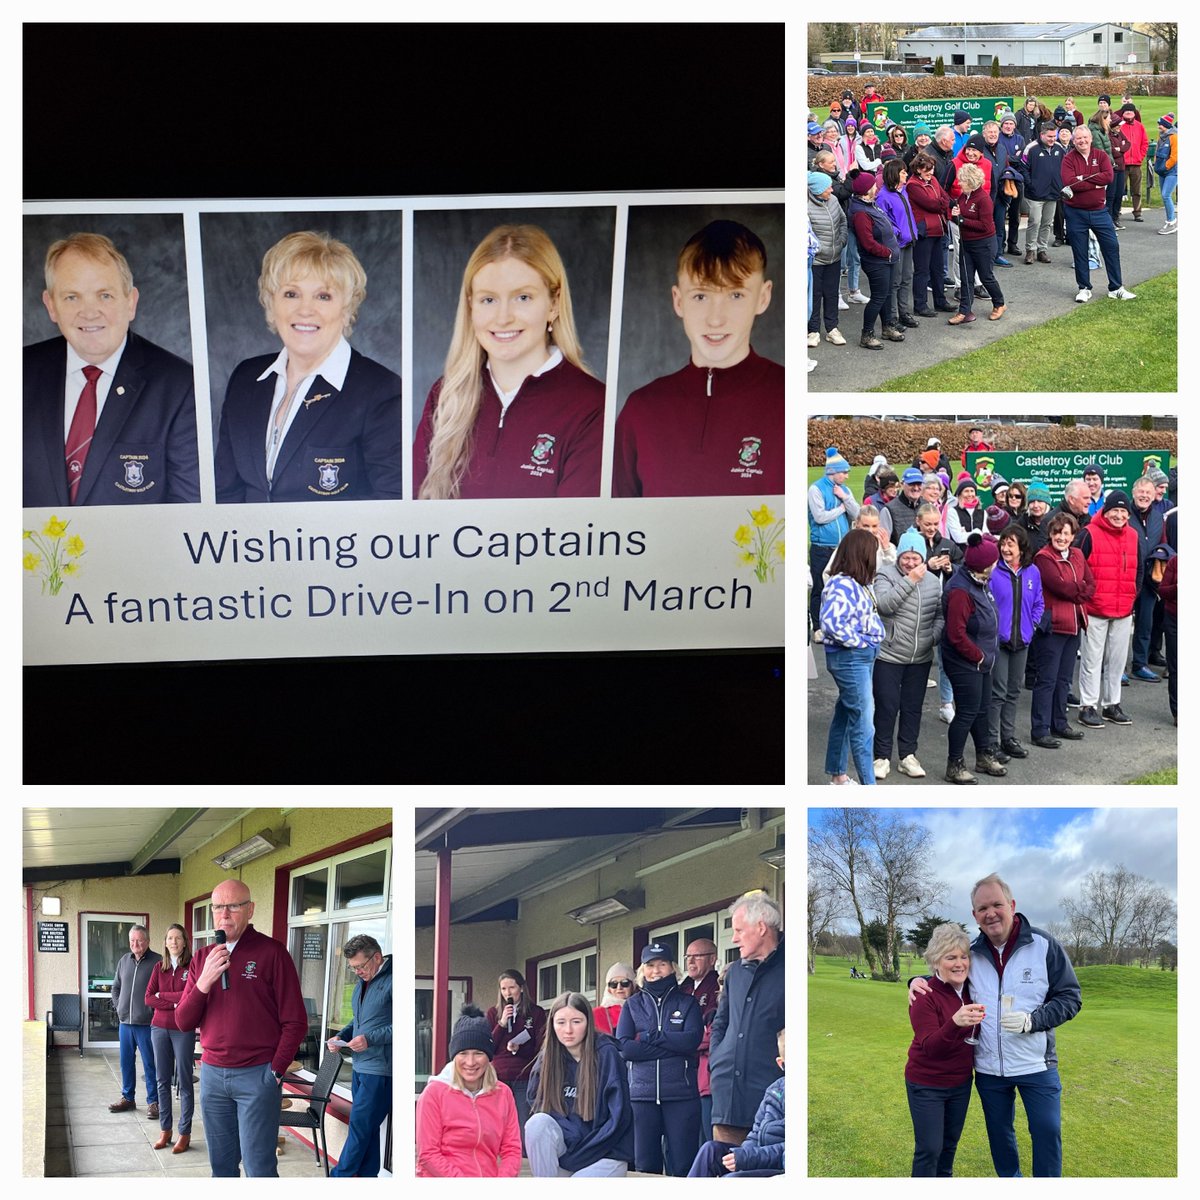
175 925 308 1073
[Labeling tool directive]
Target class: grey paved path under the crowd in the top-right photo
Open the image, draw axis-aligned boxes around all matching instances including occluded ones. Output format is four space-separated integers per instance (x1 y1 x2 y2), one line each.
808 209 1178 392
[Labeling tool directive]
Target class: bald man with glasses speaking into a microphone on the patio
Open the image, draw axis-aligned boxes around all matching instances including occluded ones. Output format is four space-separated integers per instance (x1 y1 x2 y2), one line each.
175 880 308 1178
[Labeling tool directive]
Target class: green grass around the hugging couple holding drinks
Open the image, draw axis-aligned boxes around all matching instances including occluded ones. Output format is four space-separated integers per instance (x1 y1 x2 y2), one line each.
809 956 1177 1177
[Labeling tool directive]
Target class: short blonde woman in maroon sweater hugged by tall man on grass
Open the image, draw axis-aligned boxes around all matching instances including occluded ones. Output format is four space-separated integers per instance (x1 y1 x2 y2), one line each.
904 924 984 1177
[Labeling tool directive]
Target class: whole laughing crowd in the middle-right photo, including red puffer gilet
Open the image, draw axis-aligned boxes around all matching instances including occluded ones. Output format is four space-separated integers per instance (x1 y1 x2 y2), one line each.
808 428 1178 785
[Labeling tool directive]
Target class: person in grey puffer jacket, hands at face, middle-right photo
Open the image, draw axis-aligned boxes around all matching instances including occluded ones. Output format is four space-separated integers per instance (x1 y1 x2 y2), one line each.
871 528 944 779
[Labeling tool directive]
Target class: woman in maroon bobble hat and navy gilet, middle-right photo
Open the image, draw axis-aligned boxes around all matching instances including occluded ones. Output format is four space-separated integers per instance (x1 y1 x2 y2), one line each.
941 530 1008 784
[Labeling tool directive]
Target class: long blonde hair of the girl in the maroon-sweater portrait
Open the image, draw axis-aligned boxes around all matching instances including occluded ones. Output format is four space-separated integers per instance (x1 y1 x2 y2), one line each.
418 224 590 500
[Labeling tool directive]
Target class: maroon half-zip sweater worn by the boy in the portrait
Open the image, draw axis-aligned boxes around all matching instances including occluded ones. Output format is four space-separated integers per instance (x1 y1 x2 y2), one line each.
612 349 784 497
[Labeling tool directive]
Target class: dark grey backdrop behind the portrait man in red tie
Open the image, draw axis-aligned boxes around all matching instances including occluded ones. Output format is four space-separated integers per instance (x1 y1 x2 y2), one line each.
22 212 194 360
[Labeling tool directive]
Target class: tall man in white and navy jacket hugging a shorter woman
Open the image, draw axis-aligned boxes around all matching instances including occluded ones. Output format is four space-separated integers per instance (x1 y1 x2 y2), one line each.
910 875 1084 1178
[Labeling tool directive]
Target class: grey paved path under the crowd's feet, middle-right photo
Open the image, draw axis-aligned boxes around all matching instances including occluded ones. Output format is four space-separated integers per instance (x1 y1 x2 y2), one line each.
808 638 1178 797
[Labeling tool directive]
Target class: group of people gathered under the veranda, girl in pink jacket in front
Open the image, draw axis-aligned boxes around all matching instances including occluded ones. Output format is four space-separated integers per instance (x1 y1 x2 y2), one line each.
416 892 785 1177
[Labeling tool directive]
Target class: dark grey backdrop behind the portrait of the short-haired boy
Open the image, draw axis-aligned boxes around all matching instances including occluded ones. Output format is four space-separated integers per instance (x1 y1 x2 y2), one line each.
617 204 784 413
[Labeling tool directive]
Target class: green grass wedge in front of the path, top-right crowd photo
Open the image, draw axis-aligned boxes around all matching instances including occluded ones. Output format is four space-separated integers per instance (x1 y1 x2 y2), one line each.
870 270 1178 392
